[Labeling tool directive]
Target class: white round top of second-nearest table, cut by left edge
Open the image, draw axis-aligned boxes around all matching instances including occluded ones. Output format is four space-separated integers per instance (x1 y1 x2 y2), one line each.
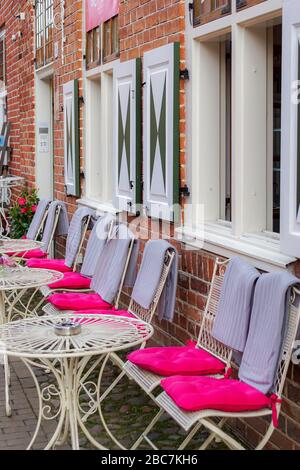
0 266 64 291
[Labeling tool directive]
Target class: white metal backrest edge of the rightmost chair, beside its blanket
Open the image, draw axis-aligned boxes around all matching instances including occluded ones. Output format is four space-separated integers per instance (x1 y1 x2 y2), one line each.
274 287 300 397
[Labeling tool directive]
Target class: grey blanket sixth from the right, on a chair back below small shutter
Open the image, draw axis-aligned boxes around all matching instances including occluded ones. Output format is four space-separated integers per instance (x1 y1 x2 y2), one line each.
65 207 95 268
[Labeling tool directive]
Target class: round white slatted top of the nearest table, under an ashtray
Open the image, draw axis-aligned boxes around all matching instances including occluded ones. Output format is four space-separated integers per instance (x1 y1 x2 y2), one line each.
0 313 154 360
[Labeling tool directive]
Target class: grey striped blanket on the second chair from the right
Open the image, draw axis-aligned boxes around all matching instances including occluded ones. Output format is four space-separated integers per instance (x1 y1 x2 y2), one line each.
212 258 260 352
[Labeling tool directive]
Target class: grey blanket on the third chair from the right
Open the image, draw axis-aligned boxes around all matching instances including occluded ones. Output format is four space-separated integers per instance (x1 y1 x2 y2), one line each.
132 240 178 321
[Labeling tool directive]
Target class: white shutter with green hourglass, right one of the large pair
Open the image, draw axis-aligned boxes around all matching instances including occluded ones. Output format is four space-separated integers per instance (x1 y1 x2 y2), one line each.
144 43 179 221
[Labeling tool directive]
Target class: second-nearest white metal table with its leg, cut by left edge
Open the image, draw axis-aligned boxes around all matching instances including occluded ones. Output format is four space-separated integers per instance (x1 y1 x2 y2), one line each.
0 266 63 416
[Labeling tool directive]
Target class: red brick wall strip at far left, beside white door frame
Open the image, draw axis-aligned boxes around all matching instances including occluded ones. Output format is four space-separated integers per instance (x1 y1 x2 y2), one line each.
0 0 35 186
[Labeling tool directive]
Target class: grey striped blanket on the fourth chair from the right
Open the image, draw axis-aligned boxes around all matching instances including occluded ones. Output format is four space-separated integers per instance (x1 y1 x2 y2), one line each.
91 225 135 304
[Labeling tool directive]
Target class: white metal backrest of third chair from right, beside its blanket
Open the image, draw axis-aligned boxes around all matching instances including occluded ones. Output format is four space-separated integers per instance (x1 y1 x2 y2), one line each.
128 250 176 323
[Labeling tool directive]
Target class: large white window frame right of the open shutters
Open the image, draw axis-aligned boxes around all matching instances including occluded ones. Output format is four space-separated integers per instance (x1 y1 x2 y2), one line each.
177 0 295 269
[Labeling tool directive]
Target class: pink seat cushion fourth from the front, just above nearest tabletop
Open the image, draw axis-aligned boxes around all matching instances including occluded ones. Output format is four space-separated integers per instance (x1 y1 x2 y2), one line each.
48 292 112 311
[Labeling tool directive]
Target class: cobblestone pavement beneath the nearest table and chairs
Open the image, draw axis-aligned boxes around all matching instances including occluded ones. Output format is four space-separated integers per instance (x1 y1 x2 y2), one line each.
0 352 229 450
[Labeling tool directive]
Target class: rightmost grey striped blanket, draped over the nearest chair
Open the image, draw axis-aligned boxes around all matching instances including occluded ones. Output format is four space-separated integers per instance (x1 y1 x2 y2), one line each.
239 272 299 393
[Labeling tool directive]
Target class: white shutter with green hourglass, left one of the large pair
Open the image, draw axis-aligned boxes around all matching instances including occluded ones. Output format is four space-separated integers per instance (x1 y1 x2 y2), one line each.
113 59 142 214
